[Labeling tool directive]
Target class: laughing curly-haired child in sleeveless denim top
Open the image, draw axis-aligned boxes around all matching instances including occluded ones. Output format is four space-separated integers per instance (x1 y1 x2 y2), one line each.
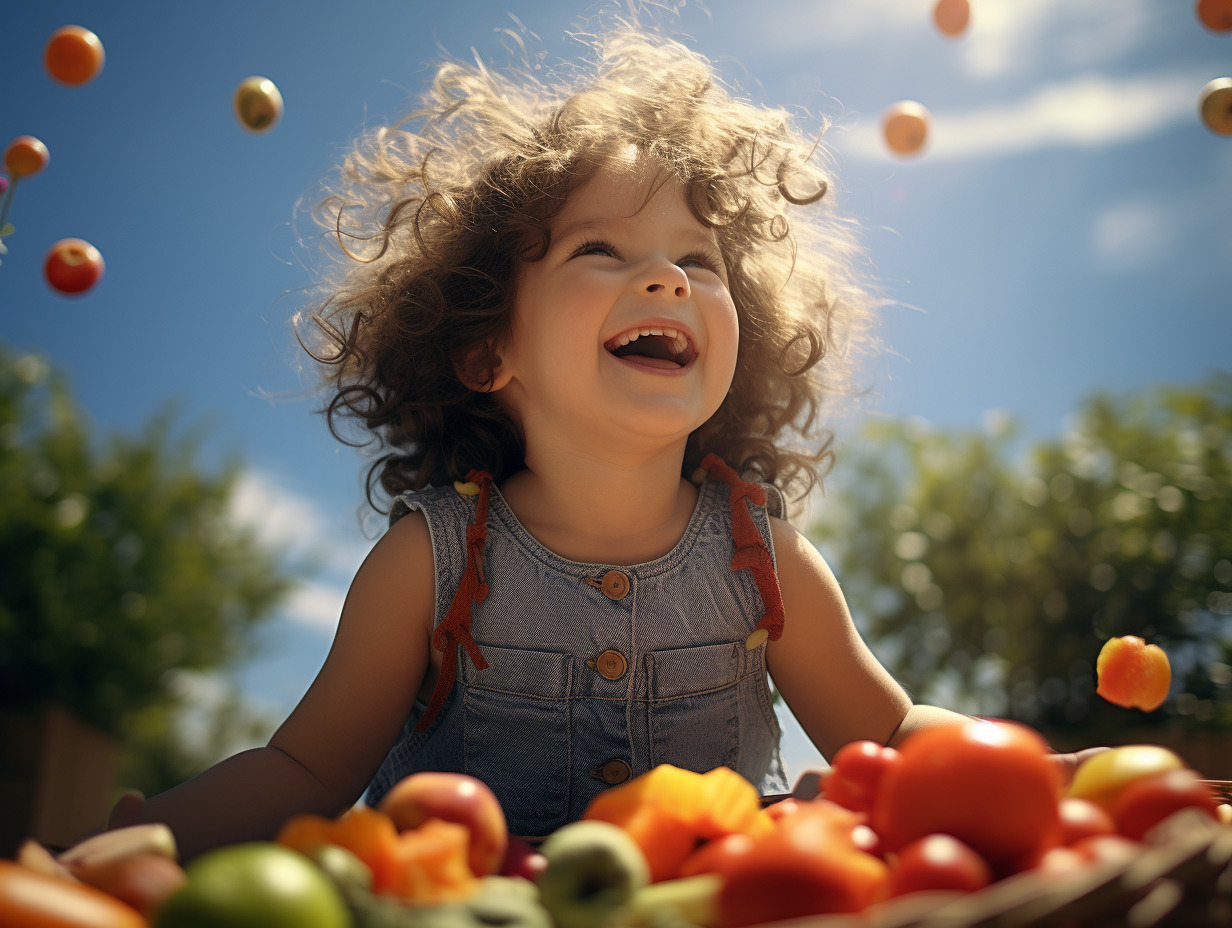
112 23 995 857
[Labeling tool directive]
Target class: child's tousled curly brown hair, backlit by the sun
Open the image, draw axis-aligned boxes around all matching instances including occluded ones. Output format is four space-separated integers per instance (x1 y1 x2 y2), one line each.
296 23 872 509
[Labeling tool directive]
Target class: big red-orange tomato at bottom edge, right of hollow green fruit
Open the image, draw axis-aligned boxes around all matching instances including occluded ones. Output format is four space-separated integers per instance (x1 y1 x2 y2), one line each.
718 800 888 928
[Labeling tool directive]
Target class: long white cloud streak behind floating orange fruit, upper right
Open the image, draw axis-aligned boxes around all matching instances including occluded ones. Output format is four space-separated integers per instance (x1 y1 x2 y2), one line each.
835 73 1201 160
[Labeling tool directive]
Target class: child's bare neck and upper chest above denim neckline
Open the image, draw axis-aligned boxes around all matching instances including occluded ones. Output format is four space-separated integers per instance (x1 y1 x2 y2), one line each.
501 442 697 564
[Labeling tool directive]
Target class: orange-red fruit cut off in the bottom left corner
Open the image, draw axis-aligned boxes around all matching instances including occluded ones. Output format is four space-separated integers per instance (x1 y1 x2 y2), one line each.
0 860 145 928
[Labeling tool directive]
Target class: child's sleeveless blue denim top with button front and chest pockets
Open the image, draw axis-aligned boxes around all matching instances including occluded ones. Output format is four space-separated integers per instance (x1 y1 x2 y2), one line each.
366 479 787 838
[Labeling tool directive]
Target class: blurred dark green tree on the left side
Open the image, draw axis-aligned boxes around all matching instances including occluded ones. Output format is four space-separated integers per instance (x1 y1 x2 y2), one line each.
0 344 291 792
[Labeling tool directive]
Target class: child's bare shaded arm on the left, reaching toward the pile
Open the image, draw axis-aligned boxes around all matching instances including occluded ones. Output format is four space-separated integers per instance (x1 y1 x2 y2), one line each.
104 513 435 859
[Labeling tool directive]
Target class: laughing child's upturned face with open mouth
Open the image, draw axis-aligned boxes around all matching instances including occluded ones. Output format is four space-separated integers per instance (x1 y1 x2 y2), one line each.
496 158 739 463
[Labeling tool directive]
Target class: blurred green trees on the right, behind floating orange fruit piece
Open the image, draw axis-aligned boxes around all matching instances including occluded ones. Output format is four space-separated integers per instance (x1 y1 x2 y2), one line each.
811 373 1232 743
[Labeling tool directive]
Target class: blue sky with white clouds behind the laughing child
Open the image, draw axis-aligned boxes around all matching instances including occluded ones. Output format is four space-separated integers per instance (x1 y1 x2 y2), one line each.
0 0 1232 783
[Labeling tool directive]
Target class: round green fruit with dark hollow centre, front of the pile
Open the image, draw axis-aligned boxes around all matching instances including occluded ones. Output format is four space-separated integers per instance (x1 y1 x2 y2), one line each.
536 820 649 928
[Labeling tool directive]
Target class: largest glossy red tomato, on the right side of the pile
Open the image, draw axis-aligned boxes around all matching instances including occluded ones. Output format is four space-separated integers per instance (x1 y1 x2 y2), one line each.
871 721 1061 874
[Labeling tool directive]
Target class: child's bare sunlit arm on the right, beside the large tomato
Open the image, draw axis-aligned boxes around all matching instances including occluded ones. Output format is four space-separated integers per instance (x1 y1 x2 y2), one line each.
766 519 971 758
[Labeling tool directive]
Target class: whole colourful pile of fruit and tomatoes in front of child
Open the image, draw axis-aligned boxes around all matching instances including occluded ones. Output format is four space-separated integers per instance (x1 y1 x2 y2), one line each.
0 721 1232 928
